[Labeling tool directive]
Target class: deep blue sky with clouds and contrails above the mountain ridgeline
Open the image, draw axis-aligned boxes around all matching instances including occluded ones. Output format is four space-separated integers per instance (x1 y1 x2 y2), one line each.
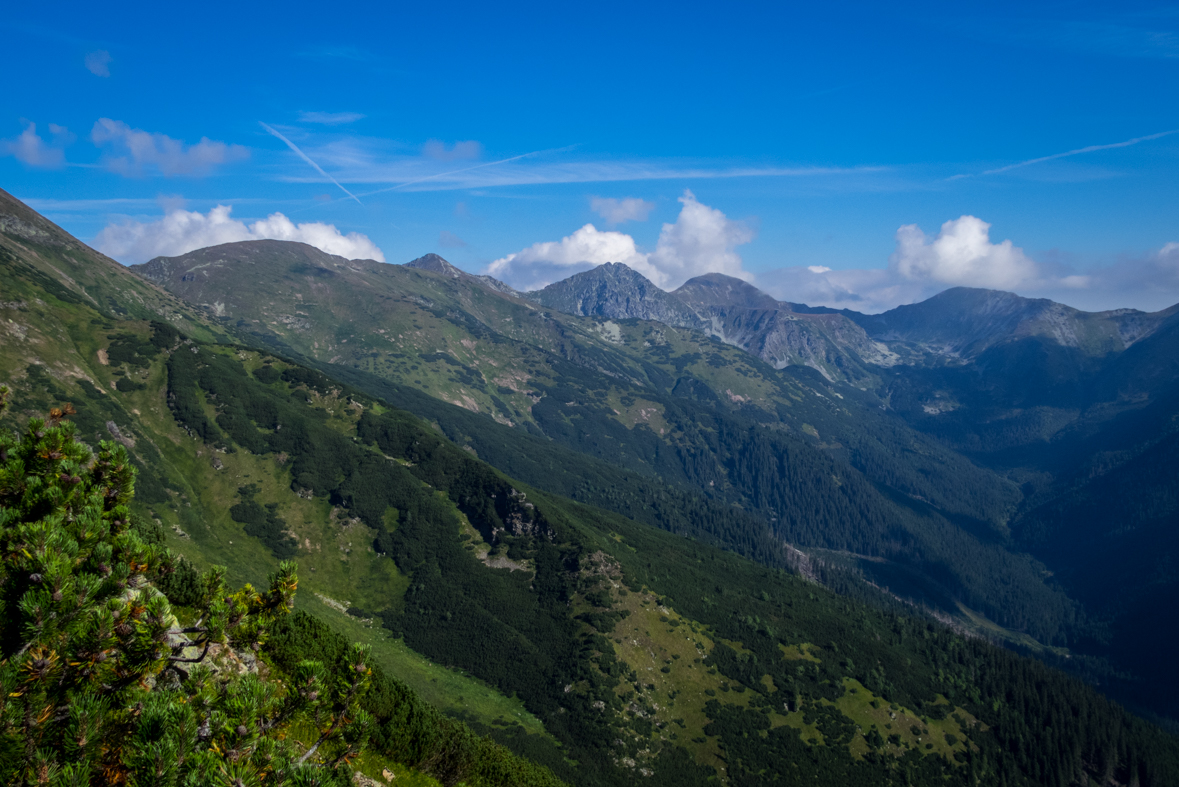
0 2 1179 311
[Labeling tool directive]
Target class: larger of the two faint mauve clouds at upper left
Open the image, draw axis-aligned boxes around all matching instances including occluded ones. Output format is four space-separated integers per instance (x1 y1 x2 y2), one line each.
90 118 250 177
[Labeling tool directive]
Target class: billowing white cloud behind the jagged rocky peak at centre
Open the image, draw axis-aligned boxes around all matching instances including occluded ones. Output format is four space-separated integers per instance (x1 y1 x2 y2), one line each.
487 191 753 290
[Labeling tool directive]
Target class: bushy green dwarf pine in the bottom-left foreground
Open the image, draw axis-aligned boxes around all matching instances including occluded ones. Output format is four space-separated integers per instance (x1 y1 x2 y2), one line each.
0 388 560 786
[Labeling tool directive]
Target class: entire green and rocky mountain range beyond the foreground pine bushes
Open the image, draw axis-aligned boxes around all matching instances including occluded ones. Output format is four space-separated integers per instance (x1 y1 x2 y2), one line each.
0 186 1179 785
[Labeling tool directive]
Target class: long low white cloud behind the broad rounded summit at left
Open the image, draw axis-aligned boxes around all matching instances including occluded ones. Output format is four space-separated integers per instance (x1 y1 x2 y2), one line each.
93 205 384 264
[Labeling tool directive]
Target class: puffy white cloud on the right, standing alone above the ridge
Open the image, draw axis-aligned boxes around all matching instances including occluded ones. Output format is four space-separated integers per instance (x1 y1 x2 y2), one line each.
889 216 1039 290
